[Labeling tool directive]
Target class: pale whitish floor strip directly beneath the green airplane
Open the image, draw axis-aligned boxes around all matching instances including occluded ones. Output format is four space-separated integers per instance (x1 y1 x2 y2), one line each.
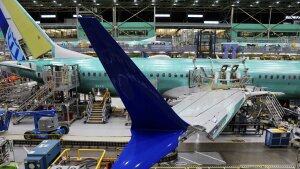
3 117 265 143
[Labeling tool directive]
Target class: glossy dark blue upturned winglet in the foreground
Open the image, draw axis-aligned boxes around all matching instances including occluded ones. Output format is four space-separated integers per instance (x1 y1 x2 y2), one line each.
79 17 189 169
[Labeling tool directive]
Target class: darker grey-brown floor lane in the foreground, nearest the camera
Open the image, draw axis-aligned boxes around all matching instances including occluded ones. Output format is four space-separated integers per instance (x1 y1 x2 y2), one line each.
9 143 297 169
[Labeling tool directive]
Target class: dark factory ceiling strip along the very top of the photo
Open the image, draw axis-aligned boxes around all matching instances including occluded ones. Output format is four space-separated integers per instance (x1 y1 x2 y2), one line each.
19 0 300 11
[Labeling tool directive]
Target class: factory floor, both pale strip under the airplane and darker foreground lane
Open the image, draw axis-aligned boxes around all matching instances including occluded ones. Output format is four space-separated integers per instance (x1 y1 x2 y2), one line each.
3 113 297 166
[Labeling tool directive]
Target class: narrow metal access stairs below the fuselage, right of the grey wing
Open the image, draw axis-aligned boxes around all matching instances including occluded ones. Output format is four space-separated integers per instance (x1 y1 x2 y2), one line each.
265 94 284 127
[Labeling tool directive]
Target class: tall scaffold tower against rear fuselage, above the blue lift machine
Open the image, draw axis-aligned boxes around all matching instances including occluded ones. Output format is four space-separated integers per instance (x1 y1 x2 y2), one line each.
43 64 79 124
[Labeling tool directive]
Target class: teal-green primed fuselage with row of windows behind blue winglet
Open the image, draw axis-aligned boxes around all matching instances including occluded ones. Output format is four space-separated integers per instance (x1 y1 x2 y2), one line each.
18 58 300 99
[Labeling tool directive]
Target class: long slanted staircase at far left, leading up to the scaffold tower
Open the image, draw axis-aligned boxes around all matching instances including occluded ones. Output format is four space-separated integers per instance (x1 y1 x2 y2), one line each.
13 85 53 124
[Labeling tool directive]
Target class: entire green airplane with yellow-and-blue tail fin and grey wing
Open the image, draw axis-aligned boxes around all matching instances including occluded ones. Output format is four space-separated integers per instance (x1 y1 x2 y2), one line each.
0 0 300 148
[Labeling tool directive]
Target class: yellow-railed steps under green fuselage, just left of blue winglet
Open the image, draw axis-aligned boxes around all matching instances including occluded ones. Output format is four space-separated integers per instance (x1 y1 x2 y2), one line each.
85 91 111 124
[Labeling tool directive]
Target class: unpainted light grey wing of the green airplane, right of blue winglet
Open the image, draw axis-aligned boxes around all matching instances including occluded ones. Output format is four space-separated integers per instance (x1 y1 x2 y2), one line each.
173 89 247 139
